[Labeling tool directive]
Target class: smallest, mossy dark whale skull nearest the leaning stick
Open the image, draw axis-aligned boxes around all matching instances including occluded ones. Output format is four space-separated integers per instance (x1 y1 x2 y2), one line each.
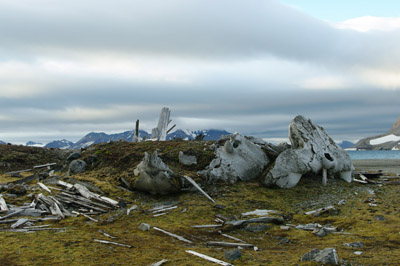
133 151 181 194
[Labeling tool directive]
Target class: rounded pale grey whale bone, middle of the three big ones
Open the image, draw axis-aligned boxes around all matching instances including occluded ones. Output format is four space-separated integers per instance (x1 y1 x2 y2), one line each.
200 133 269 183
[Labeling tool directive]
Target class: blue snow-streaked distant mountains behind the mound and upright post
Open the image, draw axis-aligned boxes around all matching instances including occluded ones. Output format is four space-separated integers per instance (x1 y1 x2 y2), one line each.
19 129 231 149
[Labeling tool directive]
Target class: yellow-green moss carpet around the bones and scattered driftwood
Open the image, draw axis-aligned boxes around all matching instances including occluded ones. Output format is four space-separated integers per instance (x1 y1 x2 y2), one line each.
0 142 400 266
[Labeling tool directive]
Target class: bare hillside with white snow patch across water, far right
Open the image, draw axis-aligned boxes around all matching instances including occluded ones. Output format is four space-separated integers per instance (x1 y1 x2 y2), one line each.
354 117 400 150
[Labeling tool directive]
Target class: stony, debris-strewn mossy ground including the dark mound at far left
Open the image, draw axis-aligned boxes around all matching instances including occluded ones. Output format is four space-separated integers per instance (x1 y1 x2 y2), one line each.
0 141 400 265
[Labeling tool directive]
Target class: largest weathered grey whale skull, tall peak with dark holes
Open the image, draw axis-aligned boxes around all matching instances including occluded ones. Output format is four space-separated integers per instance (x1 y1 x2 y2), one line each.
261 116 354 188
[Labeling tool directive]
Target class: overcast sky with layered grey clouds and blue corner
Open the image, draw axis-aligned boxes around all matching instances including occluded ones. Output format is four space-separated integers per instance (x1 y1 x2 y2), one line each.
0 0 400 143
